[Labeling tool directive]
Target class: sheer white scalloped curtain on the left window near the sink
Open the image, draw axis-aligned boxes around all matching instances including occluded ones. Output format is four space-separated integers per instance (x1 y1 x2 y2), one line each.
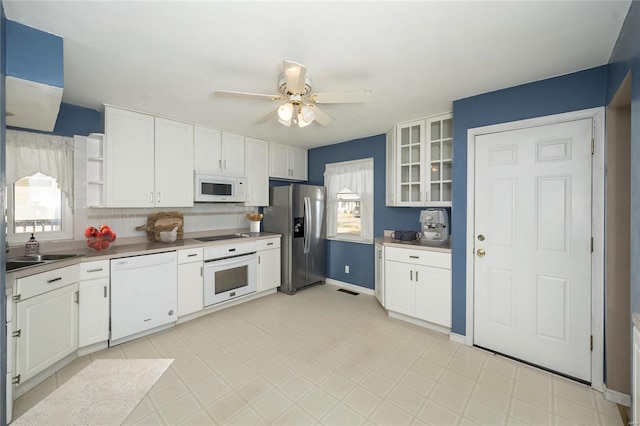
6 130 73 206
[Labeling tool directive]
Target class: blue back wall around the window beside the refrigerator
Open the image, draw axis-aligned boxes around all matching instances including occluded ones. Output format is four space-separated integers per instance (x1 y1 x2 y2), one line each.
309 131 436 289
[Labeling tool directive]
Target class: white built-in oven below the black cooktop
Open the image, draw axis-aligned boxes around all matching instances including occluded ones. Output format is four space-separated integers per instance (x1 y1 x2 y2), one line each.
204 241 257 307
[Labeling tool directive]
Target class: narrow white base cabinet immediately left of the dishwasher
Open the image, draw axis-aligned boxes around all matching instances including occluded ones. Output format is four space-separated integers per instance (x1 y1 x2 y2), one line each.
78 260 109 348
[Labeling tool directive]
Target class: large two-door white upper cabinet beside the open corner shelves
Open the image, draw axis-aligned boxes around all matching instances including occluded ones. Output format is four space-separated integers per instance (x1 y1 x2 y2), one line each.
104 106 193 207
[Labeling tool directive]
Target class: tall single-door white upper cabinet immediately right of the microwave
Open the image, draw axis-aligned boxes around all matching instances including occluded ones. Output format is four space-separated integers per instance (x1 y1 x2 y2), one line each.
244 137 269 206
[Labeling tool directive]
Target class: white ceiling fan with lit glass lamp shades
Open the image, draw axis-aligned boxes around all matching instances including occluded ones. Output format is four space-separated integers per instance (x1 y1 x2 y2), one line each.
213 61 373 127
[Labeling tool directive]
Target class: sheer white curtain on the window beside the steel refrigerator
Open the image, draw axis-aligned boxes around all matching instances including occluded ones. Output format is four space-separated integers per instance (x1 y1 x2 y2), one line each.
324 158 373 242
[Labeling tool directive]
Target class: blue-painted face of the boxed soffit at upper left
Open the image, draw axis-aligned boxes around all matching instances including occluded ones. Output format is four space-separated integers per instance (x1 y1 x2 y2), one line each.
6 21 64 87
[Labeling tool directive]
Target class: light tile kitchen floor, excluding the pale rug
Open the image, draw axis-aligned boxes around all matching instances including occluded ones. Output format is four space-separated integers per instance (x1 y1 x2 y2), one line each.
15 285 622 425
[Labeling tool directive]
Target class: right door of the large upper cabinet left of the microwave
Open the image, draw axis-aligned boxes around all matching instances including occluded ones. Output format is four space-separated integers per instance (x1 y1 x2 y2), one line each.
156 118 193 207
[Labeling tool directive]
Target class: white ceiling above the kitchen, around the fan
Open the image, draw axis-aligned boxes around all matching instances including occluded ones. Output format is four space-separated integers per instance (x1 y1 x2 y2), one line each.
3 0 630 148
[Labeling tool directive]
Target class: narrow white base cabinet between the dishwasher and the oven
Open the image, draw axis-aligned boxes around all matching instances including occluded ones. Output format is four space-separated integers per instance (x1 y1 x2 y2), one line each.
178 248 204 317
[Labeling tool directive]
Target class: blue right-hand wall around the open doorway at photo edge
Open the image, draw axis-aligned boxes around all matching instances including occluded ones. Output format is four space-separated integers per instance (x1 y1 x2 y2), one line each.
607 1 640 332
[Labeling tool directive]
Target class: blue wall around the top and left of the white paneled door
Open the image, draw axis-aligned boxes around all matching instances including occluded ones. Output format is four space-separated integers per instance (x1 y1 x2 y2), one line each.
452 66 607 335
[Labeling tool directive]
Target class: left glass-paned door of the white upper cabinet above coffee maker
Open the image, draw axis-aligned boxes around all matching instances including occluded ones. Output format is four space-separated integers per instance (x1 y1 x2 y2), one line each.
395 120 425 206
